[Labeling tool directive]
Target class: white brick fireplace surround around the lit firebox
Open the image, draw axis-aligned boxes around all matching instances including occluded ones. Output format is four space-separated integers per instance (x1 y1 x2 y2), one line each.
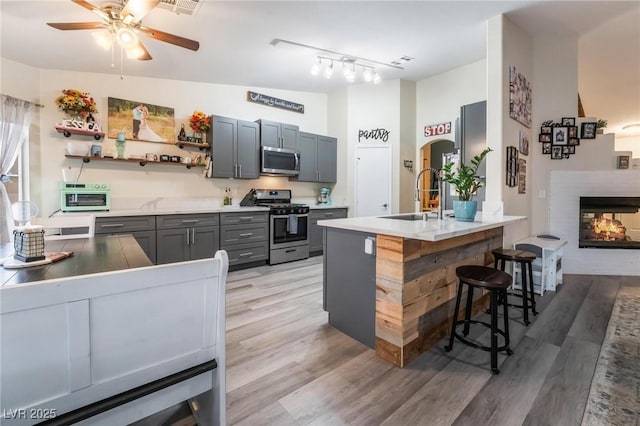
547 169 640 275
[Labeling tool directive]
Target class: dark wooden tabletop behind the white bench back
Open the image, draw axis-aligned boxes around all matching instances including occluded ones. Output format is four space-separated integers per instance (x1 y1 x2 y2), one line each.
0 234 153 287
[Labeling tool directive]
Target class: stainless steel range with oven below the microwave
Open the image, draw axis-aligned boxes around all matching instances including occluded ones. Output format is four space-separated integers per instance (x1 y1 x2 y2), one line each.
255 189 309 265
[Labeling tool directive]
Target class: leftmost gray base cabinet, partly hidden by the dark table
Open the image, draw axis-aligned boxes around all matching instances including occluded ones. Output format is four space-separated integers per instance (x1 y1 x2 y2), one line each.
95 216 156 264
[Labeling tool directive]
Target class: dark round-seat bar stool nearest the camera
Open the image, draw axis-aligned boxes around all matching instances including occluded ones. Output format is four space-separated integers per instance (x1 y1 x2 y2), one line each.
444 265 513 374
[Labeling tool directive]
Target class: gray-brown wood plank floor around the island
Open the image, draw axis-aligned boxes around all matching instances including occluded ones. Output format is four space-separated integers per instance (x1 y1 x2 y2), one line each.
227 257 640 426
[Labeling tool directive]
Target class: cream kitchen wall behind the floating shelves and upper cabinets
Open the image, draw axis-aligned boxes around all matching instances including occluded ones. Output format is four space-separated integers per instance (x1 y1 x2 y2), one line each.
2 61 333 215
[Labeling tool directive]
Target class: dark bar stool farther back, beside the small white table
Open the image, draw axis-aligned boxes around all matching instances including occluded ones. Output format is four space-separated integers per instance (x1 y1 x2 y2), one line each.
491 249 538 325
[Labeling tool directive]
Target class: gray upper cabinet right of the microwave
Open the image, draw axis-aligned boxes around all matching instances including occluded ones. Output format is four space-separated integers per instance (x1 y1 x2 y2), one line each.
291 132 338 183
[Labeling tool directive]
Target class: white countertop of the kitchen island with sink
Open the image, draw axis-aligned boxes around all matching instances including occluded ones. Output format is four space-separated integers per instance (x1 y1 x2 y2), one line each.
318 212 527 241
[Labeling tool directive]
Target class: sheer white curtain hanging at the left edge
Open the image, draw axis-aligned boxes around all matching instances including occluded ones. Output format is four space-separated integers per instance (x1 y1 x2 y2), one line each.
0 95 35 244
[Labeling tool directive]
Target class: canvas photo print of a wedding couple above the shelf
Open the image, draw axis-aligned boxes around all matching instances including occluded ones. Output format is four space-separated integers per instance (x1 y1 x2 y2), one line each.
107 98 176 143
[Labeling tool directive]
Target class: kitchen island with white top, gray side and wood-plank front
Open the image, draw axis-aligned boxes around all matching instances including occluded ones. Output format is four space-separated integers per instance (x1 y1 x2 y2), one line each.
318 214 526 367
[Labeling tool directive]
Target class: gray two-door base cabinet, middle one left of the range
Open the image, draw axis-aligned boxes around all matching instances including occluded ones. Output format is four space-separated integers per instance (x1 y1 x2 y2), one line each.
156 213 220 264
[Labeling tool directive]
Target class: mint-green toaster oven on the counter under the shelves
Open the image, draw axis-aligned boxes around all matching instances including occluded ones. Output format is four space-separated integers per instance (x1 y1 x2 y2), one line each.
60 182 111 212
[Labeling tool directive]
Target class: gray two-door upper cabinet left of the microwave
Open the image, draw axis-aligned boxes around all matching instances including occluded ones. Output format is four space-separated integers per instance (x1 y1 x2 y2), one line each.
209 115 260 179
